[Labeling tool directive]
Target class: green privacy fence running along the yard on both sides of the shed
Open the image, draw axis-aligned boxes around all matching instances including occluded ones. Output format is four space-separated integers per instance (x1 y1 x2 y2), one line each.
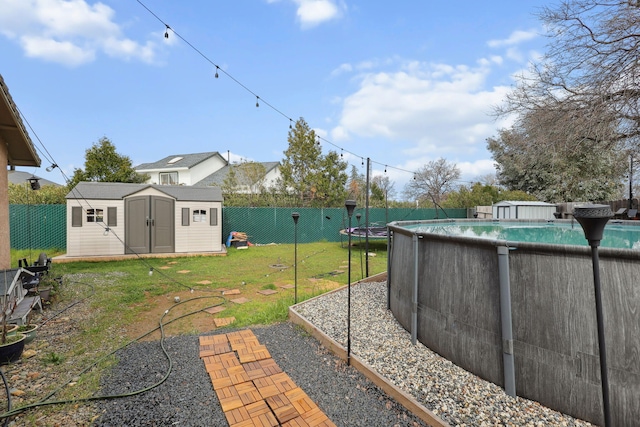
9 205 467 249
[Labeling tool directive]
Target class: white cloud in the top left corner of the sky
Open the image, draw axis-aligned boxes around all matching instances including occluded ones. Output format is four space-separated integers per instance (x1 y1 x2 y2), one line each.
0 0 158 67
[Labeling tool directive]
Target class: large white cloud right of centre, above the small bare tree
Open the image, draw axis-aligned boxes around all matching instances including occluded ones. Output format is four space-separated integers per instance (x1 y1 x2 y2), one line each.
331 61 508 159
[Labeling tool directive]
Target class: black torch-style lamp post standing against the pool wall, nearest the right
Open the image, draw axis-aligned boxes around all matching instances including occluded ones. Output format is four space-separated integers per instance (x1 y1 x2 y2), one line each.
573 205 613 427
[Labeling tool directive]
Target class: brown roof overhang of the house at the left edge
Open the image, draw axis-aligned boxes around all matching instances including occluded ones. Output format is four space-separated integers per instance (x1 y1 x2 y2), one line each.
0 75 40 166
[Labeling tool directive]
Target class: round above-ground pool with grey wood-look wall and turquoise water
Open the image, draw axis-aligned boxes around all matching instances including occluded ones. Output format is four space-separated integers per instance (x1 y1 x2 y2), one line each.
387 220 640 426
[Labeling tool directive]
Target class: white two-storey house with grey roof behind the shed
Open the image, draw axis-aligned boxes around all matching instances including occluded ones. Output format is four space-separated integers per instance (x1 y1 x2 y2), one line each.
134 151 227 185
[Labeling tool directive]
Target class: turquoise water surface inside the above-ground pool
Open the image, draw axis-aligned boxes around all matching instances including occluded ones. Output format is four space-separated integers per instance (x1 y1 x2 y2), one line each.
402 221 640 249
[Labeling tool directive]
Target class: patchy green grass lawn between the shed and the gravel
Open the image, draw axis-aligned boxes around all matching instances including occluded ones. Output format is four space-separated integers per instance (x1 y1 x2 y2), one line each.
5 242 387 420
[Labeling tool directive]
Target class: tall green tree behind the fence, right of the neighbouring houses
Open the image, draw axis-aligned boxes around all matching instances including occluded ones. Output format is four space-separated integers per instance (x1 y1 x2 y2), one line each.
279 118 348 207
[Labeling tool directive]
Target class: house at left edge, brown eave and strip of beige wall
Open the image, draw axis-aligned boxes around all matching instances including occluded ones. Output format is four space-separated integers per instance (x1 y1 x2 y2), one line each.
0 75 40 269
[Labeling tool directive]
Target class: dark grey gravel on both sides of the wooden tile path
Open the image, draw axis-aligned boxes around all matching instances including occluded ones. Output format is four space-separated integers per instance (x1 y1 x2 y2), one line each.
93 323 424 427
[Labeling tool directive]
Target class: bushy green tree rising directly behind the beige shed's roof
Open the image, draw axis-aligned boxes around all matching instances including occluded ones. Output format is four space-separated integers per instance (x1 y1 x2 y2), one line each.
67 137 149 188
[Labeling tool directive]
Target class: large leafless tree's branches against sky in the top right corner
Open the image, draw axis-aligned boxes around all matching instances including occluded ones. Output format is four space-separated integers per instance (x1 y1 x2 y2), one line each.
497 0 640 154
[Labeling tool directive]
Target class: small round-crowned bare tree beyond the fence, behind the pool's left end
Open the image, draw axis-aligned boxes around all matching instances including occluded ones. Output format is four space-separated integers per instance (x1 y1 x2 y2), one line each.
404 158 460 208
